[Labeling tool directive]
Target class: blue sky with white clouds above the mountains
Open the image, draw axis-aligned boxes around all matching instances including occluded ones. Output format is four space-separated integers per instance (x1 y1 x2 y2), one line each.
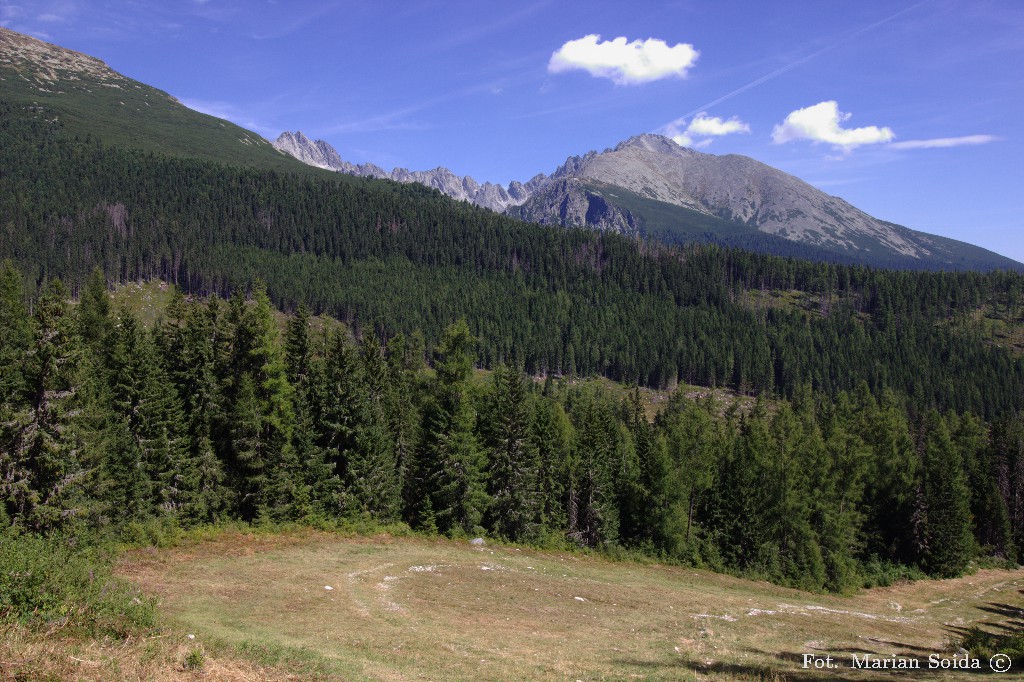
6 0 1024 261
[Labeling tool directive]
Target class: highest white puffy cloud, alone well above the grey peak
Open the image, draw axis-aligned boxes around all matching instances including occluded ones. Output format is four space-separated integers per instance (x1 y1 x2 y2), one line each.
548 35 700 85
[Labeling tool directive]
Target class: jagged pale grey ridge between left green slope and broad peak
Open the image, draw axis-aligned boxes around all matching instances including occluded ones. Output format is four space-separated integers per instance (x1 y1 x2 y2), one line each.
273 131 543 212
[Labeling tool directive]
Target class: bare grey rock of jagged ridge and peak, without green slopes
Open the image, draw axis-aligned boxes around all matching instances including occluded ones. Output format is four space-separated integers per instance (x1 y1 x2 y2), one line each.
274 132 1007 262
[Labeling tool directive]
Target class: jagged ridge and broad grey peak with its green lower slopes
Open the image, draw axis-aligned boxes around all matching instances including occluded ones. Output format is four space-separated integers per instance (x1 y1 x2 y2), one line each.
273 132 1021 269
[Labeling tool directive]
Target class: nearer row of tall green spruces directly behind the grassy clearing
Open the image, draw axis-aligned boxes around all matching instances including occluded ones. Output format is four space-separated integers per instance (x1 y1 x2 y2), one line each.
0 263 1024 590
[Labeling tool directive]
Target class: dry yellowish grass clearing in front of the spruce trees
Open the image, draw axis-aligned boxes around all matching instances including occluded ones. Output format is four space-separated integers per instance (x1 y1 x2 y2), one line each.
105 531 1024 680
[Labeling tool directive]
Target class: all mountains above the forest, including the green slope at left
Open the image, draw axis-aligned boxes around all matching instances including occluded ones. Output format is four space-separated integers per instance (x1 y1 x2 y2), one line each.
0 28 1024 270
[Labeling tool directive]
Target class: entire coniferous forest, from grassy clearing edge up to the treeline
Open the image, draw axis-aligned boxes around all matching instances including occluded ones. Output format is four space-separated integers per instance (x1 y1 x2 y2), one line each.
0 96 1024 590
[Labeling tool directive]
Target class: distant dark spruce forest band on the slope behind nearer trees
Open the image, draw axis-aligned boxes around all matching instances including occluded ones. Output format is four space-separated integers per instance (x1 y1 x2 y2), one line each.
0 104 1024 419
